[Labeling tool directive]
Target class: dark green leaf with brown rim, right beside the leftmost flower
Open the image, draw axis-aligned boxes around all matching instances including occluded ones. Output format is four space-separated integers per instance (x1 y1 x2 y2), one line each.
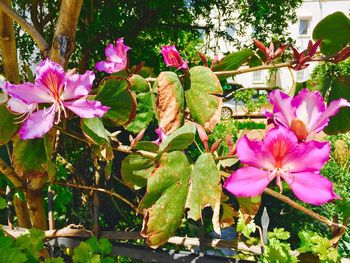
95 76 136 125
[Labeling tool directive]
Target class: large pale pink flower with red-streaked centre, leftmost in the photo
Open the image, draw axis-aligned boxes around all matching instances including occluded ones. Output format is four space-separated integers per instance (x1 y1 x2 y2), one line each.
5 59 108 140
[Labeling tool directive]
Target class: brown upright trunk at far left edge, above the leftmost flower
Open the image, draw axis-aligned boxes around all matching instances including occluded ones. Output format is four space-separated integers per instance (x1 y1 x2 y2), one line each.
0 0 20 83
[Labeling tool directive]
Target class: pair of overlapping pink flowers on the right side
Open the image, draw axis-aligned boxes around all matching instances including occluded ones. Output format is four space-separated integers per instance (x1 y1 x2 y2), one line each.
224 89 350 205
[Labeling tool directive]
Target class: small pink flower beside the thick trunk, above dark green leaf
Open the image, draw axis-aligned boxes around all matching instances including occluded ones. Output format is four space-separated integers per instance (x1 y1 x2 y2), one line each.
95 38 131 74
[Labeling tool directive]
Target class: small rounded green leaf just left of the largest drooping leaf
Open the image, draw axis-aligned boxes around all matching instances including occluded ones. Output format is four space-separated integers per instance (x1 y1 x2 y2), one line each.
121 153 154 190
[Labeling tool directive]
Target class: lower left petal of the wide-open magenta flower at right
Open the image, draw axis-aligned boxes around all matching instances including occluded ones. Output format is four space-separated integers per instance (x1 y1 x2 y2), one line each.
224 166 270 196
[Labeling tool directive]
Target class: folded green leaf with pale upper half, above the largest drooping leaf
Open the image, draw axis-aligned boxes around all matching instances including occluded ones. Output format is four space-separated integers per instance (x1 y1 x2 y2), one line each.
159 123 196 152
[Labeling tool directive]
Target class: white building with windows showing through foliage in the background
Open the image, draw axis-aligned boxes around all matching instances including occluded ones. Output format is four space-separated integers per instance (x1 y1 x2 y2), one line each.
204 0 350 91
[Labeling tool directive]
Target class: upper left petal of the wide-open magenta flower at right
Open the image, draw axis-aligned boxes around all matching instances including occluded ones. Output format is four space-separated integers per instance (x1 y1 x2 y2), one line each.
236 135 274 170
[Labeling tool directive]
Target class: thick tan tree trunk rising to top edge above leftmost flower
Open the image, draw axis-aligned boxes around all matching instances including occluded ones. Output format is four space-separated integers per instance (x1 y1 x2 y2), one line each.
50 0 83 67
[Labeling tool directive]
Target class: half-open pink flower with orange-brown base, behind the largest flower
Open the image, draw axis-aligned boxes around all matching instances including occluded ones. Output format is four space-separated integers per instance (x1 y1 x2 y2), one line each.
267 89 350 140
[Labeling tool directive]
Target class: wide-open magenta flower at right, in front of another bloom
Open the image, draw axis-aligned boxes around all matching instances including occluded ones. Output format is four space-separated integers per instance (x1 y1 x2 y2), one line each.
224 127 339 205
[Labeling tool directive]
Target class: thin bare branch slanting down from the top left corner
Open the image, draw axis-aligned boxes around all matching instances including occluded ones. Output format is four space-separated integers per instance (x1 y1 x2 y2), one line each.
0 0 49 52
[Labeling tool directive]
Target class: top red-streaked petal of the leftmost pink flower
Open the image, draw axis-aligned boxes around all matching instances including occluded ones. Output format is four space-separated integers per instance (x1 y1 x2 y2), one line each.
35 59 66 97
